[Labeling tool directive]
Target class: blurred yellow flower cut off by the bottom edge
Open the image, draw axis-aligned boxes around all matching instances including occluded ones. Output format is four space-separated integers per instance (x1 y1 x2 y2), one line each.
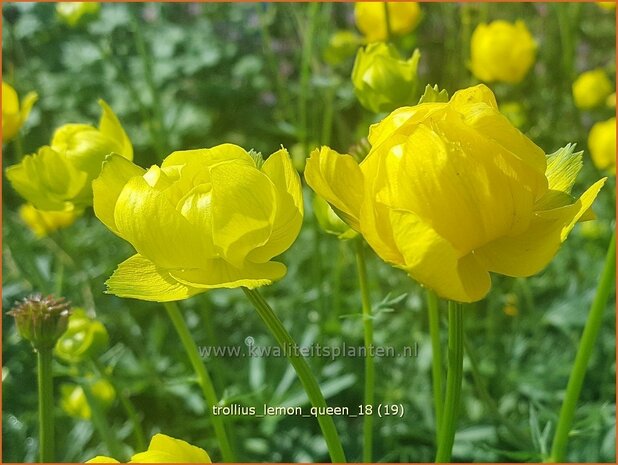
86 434 211 463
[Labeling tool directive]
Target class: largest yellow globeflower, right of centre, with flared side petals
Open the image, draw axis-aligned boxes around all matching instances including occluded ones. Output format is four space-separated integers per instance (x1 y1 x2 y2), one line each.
305 85 605 302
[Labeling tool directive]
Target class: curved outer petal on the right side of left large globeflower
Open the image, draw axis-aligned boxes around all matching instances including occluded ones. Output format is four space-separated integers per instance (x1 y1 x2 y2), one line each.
247 149 303 263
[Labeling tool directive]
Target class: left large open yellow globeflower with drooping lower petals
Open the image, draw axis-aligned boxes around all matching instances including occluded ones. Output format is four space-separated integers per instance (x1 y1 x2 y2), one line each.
93 144 303 302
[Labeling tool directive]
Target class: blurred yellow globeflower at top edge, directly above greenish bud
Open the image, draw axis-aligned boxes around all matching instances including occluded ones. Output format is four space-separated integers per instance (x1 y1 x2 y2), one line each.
354 2 421 42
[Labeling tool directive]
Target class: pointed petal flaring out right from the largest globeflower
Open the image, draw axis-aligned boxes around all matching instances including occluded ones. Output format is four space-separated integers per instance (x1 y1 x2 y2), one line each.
474 179 605 277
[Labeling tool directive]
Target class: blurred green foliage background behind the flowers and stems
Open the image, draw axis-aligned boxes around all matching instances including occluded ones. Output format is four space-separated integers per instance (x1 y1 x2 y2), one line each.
2 2 616 462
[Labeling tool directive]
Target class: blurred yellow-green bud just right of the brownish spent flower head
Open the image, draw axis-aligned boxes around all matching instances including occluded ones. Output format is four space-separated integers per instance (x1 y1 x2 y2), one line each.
54 308 109 363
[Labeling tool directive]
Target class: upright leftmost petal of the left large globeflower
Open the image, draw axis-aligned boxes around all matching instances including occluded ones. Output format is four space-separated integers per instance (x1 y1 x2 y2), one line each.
92 153 146 235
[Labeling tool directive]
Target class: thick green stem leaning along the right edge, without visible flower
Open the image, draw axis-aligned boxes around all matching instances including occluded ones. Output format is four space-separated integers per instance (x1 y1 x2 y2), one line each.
546 231 616 463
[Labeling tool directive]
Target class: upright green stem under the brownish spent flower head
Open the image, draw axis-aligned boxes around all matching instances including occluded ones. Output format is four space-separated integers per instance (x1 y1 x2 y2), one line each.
37 347 54 463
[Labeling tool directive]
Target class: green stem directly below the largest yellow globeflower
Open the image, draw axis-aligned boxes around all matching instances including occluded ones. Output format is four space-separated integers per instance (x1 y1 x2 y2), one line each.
436 302 463 463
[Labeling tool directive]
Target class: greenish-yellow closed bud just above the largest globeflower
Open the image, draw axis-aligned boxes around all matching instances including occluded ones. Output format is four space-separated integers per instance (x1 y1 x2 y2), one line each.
352 42 421 113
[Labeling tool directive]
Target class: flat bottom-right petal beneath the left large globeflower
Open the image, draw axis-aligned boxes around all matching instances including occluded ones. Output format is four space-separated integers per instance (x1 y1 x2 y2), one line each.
170 259 287 289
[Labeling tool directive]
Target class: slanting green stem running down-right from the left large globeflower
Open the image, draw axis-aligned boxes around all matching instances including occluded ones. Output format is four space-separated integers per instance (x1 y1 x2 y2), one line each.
242 287 346 463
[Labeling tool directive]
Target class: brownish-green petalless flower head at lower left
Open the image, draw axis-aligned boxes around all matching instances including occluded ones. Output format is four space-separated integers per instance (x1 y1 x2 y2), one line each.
8 294 70 351
